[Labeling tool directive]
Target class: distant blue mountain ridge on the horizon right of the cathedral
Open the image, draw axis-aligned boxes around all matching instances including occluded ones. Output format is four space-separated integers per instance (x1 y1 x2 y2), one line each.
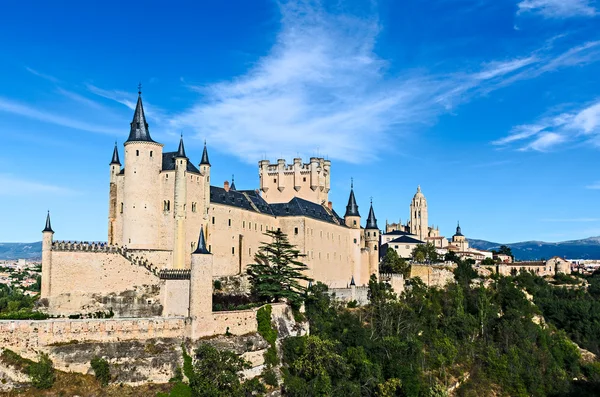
469 237 600 261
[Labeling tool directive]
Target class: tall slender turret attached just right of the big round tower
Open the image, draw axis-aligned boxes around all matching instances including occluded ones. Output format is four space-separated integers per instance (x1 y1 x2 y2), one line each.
173 136 189 269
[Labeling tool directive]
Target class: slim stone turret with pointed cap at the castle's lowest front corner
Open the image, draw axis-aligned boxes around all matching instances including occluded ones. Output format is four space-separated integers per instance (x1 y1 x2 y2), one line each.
190 227 213 339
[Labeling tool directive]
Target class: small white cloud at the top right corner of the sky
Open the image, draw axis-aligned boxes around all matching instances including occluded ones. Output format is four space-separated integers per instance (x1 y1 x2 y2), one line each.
517 0 598 18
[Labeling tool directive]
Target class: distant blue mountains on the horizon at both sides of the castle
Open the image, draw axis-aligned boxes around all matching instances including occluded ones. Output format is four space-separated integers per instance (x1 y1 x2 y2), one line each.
0 237 600 261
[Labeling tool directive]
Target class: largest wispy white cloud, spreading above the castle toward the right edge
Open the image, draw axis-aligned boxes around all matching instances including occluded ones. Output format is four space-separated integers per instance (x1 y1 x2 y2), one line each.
170 1 600 162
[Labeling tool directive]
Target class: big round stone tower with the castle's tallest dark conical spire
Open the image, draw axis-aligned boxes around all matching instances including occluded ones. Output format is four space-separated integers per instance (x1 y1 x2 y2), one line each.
119 91 163 249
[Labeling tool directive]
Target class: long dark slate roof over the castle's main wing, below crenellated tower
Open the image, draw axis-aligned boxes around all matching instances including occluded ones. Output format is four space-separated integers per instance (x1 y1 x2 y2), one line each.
210 186 344 225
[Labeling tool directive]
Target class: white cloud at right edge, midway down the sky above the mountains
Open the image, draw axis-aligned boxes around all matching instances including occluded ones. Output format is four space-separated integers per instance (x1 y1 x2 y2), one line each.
492 101 600 152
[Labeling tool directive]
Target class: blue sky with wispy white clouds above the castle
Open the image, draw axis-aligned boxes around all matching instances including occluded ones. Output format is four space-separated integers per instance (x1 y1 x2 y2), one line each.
0 0 600 242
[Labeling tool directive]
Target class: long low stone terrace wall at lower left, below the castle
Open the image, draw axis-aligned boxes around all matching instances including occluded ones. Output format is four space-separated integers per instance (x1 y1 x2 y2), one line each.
0 317 190 351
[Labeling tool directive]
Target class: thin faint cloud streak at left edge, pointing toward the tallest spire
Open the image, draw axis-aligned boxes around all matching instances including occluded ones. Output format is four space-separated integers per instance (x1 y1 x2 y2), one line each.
0 97 119 135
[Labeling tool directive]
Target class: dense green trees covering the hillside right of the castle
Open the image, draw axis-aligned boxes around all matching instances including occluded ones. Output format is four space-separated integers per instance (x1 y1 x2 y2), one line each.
282 261 600 397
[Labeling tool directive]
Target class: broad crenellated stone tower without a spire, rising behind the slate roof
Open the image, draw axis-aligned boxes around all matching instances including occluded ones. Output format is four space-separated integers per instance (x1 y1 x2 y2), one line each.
258 157 331 204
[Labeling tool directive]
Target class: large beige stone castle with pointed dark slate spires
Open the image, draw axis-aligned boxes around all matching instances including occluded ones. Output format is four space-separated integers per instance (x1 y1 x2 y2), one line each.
41 92 380 324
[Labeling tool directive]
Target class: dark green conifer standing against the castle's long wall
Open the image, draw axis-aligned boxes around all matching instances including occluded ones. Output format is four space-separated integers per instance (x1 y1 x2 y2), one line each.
247 230 311 307
